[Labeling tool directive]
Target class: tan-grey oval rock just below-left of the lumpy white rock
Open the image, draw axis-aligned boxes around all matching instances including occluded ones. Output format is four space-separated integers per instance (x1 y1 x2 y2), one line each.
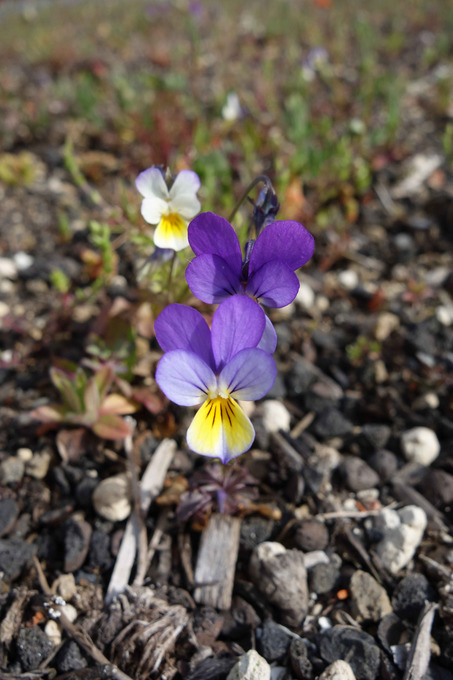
349 569 392 622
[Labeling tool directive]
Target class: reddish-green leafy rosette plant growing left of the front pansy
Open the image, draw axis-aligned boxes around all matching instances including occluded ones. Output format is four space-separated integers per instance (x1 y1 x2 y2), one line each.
31 365 138 439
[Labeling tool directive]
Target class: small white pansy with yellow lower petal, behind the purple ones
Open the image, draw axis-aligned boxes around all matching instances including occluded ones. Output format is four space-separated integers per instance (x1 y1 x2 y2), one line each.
135 167 200 250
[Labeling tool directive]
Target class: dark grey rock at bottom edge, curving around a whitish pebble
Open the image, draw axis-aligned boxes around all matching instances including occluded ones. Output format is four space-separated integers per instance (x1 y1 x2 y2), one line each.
319 626 381 680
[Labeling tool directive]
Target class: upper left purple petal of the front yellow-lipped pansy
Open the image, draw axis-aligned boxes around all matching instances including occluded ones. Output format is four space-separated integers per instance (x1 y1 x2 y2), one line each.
154 304 214 367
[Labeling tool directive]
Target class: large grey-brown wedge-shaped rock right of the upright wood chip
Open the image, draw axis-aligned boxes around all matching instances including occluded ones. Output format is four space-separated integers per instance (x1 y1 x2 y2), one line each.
249 542 308 627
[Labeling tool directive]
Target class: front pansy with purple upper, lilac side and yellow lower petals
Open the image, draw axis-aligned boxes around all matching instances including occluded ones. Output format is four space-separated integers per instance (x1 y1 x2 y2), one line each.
154 296 277 463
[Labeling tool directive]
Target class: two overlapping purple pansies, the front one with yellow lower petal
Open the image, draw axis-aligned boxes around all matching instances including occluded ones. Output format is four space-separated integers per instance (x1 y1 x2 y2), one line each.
155 197 314 463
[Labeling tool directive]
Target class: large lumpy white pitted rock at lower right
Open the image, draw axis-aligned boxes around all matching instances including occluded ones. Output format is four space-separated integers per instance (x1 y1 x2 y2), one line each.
375 505 427 574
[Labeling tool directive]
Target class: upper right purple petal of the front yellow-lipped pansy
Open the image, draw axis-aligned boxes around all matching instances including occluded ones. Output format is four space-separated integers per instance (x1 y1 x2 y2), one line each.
211 295 266 371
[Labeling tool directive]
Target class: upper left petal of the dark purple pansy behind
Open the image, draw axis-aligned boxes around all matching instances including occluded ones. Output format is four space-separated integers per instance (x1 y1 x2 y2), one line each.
189 213 242 277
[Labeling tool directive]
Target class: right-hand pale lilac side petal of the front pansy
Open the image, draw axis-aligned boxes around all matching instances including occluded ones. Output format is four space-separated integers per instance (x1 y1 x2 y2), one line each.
219 349 277 401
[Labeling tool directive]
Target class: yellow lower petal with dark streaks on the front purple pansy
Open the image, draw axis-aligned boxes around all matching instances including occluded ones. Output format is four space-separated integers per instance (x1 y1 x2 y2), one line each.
187 397 255 463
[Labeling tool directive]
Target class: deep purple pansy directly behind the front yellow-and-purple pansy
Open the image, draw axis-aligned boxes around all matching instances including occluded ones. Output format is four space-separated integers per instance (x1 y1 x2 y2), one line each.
186 213 315 307
